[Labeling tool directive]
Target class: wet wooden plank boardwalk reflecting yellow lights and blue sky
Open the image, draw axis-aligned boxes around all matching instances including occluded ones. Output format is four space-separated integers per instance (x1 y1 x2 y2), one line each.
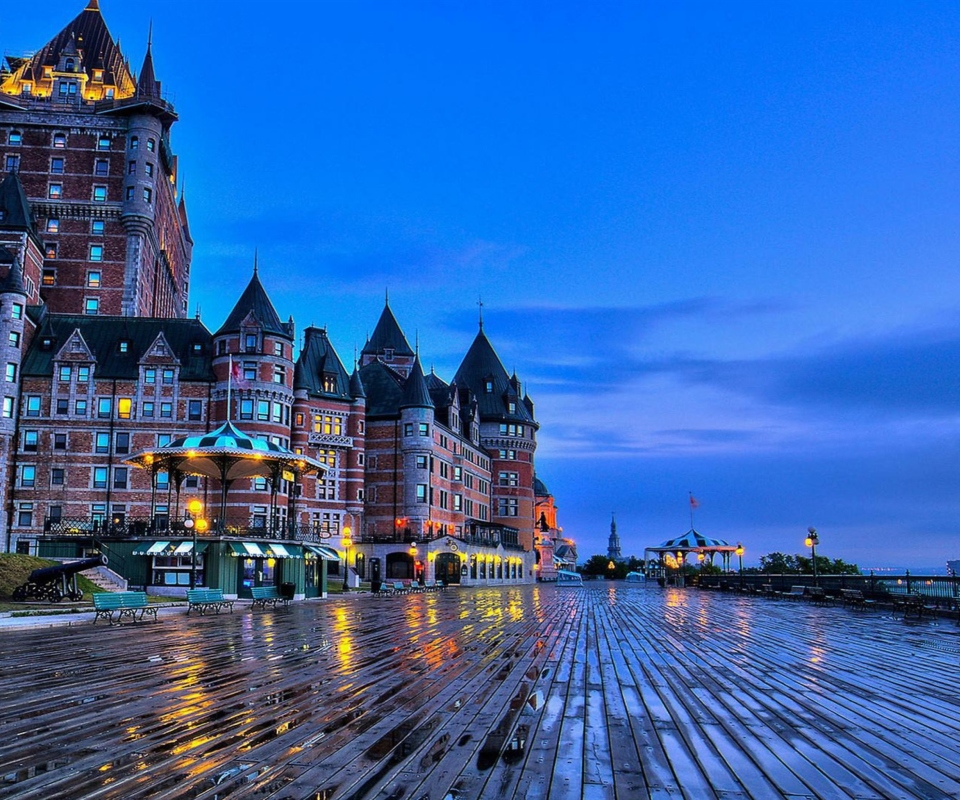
0 585 960 800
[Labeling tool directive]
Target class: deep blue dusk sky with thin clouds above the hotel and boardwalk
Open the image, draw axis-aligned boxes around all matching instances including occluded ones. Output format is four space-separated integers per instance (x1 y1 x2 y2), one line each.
0 0 960 568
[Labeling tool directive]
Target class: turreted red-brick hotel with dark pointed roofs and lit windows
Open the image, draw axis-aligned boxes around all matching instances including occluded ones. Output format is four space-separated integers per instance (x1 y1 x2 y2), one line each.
0 0 559 586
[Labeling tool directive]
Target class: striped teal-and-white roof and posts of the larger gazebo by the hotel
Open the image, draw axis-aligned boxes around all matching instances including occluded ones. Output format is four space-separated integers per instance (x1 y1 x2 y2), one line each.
124 421 326 534
